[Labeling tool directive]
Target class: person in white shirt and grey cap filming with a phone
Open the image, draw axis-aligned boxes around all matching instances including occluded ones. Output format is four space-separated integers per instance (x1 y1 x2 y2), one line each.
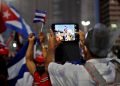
45 24 116 86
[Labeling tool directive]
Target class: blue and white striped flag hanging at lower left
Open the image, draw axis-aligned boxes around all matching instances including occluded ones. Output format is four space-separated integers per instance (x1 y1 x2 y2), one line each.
7 41 33 86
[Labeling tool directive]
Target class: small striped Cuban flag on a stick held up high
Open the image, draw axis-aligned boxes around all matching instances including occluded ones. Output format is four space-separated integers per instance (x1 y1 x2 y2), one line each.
33 10 46 23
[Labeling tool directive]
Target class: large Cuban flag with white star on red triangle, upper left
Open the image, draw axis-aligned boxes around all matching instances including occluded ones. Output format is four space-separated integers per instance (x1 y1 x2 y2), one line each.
1 3 32 38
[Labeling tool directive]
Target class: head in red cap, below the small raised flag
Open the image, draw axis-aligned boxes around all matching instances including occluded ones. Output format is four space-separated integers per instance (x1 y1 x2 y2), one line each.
34 55 45 75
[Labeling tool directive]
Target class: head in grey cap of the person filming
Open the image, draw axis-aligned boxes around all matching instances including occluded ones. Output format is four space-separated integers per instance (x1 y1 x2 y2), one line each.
85 24 110 58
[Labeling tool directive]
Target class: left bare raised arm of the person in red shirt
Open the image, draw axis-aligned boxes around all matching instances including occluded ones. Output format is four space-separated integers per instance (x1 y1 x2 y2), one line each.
26 34 36 75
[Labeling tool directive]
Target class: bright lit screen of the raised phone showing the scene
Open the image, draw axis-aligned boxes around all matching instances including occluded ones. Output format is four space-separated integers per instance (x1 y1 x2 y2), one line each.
54 24 76 41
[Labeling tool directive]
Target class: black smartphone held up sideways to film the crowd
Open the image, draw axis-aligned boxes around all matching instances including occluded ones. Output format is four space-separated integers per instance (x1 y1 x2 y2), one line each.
52 23 79 42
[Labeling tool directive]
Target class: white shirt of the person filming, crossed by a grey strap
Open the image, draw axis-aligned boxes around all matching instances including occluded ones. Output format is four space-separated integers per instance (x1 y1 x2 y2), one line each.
48 59 115 86
